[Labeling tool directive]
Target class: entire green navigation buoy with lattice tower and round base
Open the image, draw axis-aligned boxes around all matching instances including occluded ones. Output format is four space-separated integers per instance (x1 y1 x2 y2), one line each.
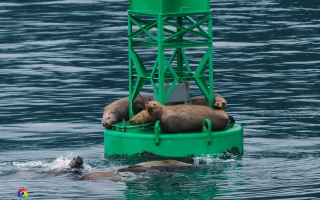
104 0 243 157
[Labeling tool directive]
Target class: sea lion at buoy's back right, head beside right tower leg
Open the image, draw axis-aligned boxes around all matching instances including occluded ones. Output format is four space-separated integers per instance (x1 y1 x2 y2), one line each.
191 93 227 109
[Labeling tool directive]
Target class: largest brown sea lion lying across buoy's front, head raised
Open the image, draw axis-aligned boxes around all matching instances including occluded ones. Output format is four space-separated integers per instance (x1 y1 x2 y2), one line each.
145 101 229 133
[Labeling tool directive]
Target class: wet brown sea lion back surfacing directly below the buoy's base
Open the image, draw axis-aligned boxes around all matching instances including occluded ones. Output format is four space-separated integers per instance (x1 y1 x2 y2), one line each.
118 160 192 172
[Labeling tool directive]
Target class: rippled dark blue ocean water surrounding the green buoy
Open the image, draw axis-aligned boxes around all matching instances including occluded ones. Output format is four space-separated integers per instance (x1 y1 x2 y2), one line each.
0 0 320 200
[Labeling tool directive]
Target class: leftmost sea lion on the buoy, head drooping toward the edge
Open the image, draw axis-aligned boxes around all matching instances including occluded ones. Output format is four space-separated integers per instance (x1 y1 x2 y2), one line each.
101 95 152 128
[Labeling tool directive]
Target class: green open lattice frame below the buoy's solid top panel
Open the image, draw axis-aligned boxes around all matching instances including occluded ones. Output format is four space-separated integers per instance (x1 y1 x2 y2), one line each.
128 11 214 118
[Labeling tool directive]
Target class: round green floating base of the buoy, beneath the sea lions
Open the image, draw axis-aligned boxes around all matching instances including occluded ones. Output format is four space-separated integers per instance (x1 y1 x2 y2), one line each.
104 120 243 157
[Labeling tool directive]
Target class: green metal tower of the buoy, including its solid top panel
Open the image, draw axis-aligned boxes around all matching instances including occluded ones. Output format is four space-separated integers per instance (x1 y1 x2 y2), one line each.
128 0 214 118
